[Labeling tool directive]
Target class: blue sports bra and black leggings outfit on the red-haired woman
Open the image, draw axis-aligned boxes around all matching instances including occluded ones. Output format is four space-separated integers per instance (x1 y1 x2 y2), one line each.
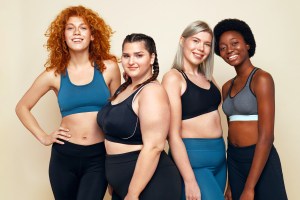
49 68 110 200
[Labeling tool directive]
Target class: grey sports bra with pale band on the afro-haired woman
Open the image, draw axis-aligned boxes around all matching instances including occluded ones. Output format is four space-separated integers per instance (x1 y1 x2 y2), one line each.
222 67 259 121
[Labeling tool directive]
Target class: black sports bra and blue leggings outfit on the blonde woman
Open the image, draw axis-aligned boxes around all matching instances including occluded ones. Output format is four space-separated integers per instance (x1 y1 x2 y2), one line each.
178 70 226 200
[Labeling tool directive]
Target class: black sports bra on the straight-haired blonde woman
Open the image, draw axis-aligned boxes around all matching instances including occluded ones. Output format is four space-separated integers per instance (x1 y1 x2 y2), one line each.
178 70 221 120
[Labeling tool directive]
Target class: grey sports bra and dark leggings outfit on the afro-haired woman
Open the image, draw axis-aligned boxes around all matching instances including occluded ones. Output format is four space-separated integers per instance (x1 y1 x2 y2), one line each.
223 68 287 200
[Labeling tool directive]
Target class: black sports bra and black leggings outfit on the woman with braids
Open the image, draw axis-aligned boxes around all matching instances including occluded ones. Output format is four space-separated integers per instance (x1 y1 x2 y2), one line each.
97 83 181 200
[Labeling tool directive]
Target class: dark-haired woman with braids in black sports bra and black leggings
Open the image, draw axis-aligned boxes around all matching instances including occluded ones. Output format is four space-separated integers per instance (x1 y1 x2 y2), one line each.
97 34 181 200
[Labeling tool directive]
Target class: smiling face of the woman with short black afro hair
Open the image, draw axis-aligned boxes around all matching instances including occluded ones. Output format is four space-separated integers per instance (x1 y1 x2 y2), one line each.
219 31 250 66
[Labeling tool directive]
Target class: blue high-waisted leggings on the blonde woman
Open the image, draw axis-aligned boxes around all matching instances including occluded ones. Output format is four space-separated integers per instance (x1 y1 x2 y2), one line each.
181 138 226 200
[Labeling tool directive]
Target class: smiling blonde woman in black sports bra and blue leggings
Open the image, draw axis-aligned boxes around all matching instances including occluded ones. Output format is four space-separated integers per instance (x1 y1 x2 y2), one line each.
162 21 226 200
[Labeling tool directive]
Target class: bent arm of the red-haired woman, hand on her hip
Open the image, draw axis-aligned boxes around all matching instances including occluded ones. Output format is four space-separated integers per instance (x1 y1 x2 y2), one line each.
16 71 70 146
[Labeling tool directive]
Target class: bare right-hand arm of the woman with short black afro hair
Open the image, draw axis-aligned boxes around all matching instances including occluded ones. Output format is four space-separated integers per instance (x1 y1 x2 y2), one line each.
241 70 275 199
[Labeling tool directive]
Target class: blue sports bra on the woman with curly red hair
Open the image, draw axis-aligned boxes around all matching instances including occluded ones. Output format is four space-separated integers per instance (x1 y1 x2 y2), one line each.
57 67 110 117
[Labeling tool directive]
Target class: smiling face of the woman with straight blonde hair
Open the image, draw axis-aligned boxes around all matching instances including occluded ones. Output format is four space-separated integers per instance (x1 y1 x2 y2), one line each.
180 31 212 66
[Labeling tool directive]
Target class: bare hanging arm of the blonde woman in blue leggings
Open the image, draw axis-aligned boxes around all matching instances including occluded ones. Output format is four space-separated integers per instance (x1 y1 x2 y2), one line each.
162 70 201 200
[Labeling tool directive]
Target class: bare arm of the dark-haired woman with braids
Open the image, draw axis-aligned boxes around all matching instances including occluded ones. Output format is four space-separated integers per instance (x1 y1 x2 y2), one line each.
125 83 170 199
